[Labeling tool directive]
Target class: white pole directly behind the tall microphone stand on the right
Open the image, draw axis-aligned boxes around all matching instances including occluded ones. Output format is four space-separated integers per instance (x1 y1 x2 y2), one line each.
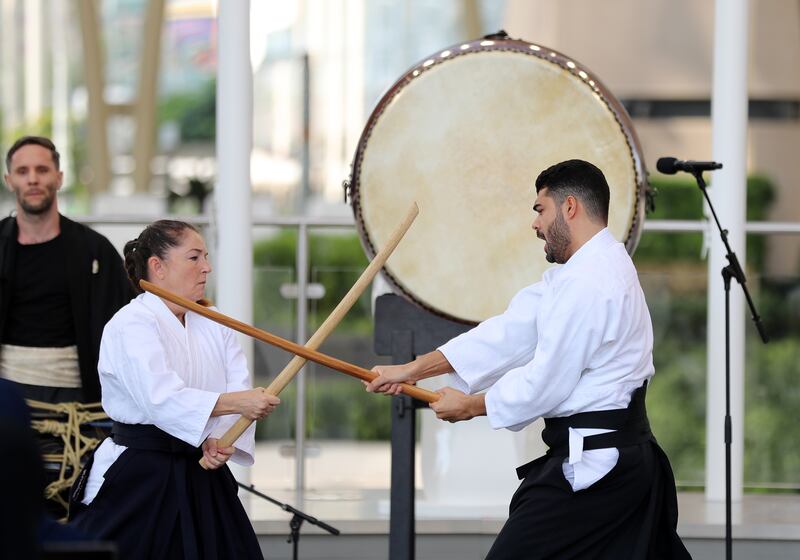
706 0 748 501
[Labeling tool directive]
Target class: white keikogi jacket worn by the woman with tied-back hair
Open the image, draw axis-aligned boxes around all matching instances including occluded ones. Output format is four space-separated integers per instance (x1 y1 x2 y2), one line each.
82 292 255 504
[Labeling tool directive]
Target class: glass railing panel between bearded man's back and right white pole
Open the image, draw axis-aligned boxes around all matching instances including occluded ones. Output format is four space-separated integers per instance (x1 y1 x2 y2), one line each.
634 232 708 488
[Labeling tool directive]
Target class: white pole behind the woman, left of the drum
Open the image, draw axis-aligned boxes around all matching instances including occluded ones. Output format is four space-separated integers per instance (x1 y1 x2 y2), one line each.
214 0 253 470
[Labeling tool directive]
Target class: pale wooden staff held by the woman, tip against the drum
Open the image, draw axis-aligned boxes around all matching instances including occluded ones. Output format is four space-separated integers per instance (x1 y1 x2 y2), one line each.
200 202 419 468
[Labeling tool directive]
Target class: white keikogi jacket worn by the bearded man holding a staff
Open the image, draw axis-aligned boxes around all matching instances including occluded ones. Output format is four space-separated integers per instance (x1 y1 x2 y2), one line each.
439 229 654 490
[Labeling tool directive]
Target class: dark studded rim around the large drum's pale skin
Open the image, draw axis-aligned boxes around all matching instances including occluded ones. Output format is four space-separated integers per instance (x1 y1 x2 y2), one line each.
346 31 648 325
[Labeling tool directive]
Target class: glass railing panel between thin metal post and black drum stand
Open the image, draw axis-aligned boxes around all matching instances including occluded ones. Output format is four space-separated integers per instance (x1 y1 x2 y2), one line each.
306 232 391 490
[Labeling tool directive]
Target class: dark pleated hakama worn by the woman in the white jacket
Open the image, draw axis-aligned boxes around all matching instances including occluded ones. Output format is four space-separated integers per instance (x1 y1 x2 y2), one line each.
70 423 263 560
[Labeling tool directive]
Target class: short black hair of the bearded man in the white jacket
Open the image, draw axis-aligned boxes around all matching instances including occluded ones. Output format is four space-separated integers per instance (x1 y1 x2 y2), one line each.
536 159 610 224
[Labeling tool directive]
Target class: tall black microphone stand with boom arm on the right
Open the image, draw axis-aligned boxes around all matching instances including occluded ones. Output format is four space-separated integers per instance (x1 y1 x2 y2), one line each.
692 170 769 560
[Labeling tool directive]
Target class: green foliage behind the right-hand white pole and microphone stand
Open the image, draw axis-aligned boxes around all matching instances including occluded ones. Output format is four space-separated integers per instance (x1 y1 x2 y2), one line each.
634 172 800 491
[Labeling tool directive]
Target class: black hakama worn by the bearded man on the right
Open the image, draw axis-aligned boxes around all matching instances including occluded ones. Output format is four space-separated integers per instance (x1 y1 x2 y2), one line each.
486 388 691 560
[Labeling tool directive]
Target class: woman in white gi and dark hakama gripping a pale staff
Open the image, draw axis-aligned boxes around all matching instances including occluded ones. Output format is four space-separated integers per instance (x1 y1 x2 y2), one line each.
70 220 280 559
